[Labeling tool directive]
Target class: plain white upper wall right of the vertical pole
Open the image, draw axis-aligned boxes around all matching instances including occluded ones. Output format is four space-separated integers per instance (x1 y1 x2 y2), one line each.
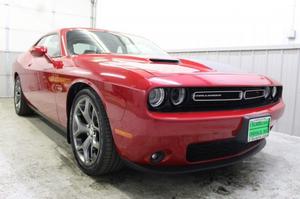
97 0 300 50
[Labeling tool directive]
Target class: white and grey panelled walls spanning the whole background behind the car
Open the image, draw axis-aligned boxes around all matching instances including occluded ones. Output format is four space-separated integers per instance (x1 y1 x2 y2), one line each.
0 0 300 136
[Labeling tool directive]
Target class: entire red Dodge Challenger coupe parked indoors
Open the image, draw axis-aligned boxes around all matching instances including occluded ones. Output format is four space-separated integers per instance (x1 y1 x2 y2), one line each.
13 28 284 175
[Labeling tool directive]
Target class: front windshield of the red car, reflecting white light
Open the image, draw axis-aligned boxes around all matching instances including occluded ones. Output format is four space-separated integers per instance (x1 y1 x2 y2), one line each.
67 30 169 57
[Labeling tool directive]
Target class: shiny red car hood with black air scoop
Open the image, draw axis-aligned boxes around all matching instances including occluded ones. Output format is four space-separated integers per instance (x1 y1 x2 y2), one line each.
73 54 274 86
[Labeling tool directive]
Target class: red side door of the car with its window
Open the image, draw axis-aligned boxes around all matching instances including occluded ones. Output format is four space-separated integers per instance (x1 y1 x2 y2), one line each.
29 34 61 122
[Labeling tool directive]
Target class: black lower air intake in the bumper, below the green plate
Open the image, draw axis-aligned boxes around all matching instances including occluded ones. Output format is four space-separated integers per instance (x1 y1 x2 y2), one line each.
186 139 262 162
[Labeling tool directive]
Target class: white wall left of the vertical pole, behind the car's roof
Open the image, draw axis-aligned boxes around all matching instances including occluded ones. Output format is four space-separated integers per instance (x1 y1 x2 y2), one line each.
0 0 91 97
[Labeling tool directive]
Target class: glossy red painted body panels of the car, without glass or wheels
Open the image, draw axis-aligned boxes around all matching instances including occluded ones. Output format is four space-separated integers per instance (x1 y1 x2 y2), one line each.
13 28 284 173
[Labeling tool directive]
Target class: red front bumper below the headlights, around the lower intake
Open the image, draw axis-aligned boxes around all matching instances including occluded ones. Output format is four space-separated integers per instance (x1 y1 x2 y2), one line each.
112 101 284 166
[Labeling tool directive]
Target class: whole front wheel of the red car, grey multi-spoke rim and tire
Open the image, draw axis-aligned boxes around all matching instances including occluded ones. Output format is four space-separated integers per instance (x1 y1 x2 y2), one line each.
69 89 122 176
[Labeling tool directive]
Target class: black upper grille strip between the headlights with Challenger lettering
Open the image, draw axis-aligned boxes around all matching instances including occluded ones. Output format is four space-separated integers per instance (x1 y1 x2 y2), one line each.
149 86 282 112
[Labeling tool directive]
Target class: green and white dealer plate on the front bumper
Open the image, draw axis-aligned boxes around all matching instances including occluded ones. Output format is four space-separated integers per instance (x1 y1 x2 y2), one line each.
248 116 271 142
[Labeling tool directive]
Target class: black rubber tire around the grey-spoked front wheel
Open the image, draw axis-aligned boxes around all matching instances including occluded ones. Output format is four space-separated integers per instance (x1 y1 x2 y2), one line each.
69 88 123 176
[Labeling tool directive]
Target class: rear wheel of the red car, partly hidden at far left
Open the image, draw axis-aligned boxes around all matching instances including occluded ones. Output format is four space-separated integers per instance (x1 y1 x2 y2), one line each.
14 76 33 116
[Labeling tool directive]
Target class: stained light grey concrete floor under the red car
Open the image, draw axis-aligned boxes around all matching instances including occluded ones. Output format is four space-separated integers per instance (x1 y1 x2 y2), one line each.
0 99 300 199
